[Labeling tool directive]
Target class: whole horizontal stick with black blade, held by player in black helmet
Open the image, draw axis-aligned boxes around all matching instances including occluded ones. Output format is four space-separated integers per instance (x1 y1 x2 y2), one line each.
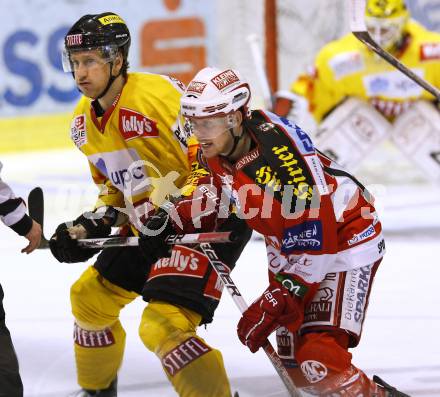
28 187 237 249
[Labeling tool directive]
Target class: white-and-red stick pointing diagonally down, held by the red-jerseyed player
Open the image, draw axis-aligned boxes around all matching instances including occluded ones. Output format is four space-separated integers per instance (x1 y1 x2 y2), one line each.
200 243 301 397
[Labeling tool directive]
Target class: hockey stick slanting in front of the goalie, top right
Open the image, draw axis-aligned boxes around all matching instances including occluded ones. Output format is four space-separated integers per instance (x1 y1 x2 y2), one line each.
348 0 440 100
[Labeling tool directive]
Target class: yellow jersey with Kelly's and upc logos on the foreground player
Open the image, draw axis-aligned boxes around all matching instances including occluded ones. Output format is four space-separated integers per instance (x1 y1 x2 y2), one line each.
71 73 198 230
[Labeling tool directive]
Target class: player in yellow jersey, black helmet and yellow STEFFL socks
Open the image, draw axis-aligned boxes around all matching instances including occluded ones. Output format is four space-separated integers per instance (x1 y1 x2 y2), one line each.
50 12 250 397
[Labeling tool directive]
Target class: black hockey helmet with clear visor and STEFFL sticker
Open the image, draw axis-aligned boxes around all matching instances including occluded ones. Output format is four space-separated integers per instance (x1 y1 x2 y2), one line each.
63 12 131 72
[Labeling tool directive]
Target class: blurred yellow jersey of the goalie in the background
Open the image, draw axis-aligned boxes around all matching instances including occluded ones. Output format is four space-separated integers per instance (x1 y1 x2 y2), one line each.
291 20 440 122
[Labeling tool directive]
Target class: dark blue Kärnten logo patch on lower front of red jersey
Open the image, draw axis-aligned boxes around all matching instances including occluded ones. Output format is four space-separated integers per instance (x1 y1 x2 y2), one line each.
281 221 322 254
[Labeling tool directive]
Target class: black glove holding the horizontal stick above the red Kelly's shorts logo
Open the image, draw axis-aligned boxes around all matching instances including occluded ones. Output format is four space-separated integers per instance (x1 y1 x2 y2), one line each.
139 210 176 263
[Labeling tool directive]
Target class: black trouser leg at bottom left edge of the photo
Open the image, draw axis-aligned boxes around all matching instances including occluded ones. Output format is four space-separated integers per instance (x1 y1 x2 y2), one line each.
0 285 23 397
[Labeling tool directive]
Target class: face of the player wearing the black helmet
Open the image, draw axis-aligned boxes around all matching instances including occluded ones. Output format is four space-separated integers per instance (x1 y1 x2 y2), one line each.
70 50 110 98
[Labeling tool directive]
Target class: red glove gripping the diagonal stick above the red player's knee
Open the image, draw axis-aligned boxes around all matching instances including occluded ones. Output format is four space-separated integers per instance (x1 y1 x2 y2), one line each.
237 281 304 353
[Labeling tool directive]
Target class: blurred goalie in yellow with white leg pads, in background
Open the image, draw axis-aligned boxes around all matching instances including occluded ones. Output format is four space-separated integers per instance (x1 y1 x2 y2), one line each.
274 0 440 181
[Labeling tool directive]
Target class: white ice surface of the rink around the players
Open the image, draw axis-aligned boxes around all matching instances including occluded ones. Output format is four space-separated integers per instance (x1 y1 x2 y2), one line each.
0 151 440 397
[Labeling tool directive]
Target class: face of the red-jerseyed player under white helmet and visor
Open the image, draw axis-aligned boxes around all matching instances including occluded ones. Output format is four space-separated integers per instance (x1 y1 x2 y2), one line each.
188 115 236 158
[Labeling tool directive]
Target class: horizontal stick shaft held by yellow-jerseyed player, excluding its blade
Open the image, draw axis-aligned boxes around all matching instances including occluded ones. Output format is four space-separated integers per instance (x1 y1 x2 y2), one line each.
78 232 235 248
